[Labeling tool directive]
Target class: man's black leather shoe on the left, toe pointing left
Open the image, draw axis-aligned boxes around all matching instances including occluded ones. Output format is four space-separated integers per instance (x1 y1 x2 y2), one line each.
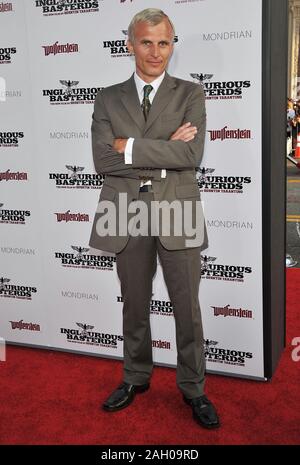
102 383 150 412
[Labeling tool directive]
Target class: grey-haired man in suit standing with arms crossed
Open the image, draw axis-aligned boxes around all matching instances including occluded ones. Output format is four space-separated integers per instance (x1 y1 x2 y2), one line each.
90 8 219 428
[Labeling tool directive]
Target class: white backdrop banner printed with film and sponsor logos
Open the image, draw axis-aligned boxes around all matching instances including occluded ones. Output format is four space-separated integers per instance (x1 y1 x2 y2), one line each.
0 0 263 378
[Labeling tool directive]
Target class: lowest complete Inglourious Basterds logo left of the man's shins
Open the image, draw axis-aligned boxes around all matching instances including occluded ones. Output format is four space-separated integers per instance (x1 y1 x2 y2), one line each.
60 323 123 349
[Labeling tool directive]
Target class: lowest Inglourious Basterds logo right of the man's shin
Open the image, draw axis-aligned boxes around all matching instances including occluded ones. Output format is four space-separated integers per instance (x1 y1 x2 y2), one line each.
204 339 253 367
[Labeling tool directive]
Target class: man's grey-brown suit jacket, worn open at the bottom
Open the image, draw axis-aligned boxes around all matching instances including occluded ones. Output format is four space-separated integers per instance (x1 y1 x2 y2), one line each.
90 73 206 253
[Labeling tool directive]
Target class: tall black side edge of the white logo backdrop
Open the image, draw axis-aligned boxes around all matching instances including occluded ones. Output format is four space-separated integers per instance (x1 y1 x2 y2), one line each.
262 0 288 379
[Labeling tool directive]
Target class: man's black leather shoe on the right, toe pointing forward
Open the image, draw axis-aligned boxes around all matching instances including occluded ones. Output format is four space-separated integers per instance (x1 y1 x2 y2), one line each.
183 396 220 429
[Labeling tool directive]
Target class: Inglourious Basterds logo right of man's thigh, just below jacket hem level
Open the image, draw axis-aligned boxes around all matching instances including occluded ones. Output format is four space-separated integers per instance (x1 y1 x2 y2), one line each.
201 255 252 282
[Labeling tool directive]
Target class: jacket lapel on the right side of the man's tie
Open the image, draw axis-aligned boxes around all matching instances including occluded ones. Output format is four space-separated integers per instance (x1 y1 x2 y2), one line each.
144 73 176 133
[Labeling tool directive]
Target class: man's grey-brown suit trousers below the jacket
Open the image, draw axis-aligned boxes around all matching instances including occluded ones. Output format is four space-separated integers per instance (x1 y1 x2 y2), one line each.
116 192 205 399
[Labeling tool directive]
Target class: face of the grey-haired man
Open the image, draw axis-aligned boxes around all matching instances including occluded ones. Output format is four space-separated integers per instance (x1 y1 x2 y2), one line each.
127 19 173 82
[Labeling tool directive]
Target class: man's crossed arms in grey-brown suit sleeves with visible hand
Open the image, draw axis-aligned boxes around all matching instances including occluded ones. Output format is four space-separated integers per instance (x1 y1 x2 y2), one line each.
92 86 206 179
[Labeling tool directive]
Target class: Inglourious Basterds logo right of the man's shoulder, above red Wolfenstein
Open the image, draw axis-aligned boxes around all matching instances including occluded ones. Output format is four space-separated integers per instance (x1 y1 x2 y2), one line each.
190 73 251 100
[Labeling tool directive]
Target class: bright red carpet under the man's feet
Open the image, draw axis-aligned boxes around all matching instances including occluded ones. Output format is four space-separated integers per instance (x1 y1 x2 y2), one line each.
0 269 300 445
